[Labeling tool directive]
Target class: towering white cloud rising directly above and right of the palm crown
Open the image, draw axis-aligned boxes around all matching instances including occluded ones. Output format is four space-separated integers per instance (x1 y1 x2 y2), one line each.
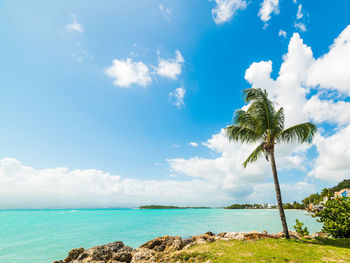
245 34 314 126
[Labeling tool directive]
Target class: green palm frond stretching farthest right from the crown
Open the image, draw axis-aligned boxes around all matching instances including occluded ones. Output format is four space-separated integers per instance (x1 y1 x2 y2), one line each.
276 122 317 143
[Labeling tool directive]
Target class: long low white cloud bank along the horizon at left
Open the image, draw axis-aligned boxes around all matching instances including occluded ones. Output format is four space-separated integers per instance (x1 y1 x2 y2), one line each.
0 158 312 209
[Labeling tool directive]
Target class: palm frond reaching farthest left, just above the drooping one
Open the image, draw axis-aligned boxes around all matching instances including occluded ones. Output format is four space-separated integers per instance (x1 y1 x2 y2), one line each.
225 125 261 143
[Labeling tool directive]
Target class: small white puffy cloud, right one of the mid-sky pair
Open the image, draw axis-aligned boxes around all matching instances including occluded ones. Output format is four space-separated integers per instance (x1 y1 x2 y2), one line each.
157 50 185 79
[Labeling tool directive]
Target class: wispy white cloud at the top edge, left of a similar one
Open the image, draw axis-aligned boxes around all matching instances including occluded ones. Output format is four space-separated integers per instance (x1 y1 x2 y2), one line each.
209 0 247 24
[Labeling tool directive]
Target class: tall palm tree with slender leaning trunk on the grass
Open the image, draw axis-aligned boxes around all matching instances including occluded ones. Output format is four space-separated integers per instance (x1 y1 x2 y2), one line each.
226 88 317 238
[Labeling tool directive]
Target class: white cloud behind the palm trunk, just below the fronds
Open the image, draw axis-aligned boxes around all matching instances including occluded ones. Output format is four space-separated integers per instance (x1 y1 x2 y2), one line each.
167 130 307 202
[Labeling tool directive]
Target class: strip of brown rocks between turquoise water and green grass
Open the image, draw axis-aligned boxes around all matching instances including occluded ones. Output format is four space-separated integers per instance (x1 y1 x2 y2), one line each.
52 231 327 263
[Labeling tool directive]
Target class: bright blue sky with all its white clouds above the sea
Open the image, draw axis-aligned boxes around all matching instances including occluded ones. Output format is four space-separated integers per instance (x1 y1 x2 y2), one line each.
0 0 350 209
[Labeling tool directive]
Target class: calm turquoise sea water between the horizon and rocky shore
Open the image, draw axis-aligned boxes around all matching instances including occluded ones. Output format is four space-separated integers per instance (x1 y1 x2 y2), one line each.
0 209 321 263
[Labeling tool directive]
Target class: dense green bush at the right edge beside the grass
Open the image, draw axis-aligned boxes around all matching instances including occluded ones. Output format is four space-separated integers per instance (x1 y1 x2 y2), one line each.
314 197 350 238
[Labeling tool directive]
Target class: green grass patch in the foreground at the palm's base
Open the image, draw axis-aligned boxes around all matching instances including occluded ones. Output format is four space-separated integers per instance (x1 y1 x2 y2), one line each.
166 239 350 263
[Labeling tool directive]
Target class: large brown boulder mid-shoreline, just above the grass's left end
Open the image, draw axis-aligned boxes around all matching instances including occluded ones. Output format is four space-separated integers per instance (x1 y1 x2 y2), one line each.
140 236 187 252
